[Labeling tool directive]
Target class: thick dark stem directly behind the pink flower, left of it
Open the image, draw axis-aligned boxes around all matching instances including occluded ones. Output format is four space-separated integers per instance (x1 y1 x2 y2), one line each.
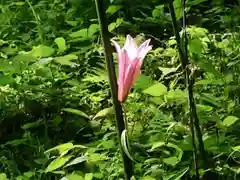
95 0 133 180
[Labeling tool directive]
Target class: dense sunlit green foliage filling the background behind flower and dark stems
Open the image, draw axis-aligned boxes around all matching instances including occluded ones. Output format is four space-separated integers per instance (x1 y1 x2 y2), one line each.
0 0 240 180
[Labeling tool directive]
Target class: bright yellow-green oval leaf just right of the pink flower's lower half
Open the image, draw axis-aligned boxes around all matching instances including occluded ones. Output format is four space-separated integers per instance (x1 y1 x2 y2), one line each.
143 83 167 96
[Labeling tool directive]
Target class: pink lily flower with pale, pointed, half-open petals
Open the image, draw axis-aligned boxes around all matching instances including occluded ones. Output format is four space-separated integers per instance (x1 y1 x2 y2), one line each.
112 35 152 102
